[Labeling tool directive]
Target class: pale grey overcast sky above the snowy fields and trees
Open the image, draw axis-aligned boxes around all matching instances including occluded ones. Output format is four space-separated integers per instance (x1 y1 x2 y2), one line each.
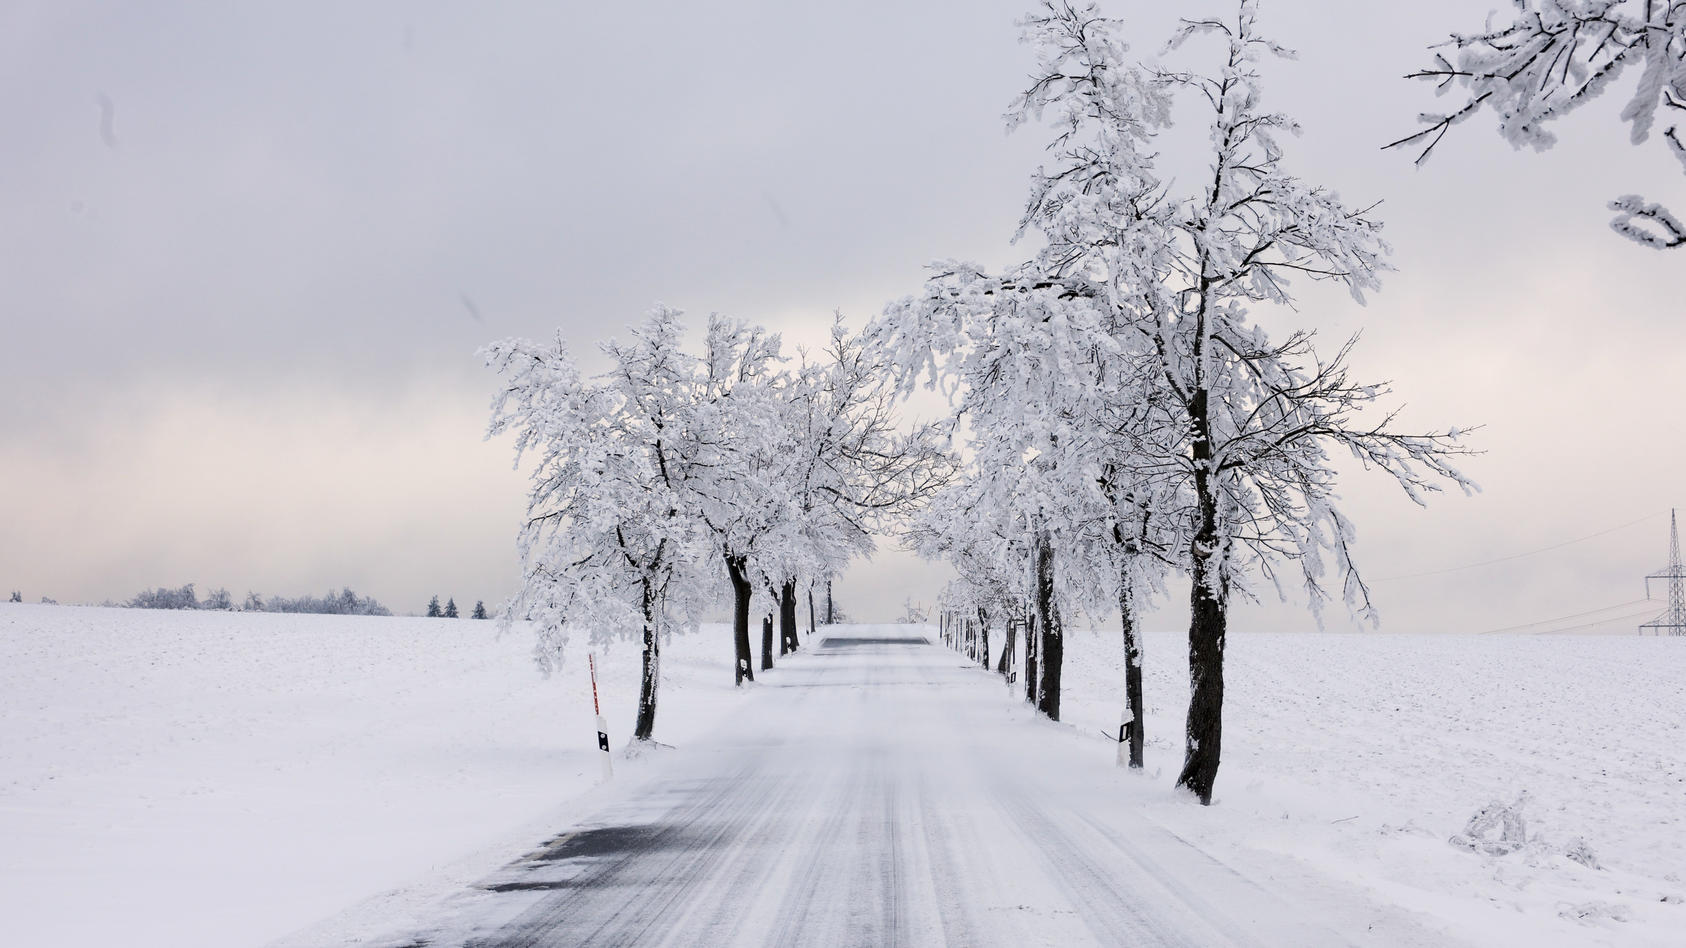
0 0 1686 633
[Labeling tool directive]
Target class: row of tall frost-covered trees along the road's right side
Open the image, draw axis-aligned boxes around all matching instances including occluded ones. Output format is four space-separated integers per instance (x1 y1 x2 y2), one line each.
870 0 1474 803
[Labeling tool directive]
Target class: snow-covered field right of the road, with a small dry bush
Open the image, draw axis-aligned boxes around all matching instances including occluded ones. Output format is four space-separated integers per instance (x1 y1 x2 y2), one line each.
1064 629 1686 945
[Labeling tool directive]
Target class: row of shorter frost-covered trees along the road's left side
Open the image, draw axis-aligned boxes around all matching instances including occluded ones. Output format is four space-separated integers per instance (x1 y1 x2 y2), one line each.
486 307 954 741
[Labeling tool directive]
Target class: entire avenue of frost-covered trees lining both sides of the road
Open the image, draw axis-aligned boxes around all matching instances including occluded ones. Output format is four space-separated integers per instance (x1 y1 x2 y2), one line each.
487 0 1474 803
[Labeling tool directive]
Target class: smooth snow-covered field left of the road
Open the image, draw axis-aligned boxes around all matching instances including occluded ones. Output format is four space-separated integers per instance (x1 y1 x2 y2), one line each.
0 606 735 948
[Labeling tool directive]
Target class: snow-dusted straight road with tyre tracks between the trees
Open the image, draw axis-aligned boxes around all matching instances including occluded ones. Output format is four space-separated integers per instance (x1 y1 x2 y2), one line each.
375 628 1345 946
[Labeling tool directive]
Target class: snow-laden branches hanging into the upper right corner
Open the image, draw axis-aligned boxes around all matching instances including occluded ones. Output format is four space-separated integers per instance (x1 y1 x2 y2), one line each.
1388 0 1686 250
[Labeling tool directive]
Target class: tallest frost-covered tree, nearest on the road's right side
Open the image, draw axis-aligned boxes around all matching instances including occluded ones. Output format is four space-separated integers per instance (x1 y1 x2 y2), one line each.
991 0 1474 803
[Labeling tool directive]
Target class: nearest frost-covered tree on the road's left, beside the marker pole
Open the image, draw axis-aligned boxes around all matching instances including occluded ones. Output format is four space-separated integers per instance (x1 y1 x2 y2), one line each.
486 307 718 741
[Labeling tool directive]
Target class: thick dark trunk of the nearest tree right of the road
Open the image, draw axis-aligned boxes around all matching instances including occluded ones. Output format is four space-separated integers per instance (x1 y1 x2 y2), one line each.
1177 391 1229 805
